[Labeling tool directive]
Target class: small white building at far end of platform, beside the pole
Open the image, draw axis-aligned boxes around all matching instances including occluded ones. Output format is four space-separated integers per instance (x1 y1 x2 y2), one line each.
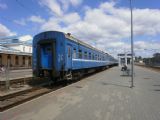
118 53 132 66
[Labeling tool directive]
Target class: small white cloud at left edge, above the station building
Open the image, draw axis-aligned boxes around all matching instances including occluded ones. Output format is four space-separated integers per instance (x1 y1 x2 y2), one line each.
0 23 16 37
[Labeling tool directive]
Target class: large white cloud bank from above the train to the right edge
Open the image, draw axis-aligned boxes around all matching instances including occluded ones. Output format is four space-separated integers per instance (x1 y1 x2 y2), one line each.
41 2 160 54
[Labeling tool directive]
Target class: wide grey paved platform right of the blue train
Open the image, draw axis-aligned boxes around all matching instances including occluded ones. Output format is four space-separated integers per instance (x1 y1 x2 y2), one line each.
0 66 160 120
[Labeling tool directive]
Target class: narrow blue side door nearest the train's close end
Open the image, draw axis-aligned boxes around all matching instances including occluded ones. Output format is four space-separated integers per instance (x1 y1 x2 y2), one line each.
67 45 72 69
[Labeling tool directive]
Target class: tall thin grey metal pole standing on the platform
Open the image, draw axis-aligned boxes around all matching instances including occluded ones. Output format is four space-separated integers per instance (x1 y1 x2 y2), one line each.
130 0 134 88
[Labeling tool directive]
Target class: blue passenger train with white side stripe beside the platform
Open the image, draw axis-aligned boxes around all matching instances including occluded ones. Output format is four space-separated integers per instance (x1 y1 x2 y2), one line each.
32 31 117 80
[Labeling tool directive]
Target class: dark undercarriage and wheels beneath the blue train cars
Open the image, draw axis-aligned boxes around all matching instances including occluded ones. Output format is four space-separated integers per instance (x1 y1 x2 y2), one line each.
34 64 117 83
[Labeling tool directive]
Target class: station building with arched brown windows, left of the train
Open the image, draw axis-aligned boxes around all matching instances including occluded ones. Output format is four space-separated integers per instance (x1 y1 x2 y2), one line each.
0 39 32 69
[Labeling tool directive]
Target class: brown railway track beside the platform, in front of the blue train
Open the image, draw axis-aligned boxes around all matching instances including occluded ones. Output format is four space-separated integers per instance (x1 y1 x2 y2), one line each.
0 81 75 112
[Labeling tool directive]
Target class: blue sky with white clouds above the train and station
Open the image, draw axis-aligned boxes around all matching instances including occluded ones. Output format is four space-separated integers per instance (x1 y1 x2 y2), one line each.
0 0 160 57
